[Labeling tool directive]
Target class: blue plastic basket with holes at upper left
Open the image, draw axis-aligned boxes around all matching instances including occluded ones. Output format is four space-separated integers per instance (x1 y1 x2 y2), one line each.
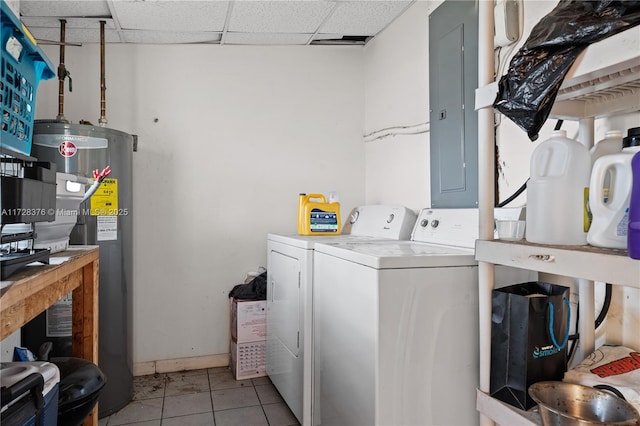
0 1 56 155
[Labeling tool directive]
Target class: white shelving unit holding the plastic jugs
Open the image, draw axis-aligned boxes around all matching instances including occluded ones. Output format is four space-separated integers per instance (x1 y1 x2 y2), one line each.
476 2 640 425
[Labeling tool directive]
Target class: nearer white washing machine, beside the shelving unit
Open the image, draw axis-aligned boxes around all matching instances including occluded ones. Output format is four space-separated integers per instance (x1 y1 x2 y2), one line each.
313 209 536 426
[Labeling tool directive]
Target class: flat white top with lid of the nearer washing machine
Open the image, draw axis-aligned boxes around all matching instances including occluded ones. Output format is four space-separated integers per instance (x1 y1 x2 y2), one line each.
315 241 478 269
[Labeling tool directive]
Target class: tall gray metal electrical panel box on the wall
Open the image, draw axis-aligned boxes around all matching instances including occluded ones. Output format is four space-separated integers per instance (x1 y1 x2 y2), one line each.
429 0 478 208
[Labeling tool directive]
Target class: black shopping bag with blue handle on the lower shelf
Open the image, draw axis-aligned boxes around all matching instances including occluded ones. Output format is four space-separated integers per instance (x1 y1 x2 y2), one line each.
489 282 570 410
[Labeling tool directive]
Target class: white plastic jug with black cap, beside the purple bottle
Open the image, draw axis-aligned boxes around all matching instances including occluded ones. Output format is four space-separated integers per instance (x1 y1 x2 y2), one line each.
587 130 640 249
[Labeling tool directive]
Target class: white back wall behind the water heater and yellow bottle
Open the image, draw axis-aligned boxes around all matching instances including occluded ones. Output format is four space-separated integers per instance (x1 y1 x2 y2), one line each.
36 45 364 371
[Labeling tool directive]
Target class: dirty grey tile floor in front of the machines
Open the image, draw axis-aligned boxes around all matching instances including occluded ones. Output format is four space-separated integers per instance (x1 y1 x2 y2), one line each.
99 367 299 426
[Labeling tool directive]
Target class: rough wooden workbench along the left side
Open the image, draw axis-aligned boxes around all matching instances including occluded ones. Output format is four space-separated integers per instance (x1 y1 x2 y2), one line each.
0 246 99 426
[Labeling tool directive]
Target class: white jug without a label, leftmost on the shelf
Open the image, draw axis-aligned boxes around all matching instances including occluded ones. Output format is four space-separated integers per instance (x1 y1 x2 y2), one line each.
526 130 591 245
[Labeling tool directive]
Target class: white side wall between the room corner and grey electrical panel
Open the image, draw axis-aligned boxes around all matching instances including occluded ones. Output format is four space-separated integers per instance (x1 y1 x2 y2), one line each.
364 1 441 210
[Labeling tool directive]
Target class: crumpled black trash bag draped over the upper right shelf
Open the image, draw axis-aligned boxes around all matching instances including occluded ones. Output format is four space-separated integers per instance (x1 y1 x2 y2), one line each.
493 0 640 141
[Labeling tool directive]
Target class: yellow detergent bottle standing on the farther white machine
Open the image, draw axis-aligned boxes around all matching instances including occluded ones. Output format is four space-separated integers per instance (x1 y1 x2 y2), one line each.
298 194 342 235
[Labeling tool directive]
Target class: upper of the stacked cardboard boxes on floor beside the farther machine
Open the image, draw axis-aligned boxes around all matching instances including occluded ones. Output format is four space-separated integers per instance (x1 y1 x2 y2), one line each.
231 299 267 343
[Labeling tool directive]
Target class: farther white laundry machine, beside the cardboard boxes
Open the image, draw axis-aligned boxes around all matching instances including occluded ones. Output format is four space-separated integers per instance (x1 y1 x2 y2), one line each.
267 205 417 426
